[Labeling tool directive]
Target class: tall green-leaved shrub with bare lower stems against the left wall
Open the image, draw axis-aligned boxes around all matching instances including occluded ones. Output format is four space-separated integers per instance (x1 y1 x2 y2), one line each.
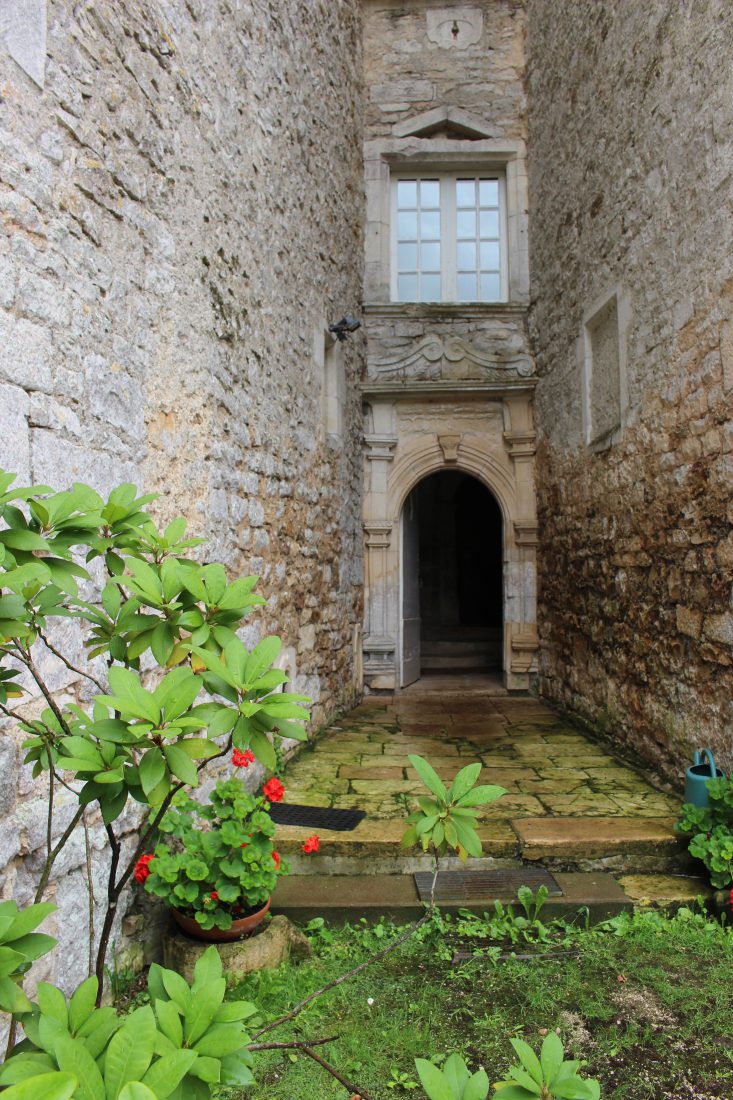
0 471 308 985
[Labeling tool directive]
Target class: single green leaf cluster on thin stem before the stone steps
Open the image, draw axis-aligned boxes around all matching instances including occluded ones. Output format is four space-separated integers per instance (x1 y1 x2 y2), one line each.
402 756 506 860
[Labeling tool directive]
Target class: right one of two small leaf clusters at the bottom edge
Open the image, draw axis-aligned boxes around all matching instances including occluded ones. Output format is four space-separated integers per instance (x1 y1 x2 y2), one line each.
494 1032 601 1100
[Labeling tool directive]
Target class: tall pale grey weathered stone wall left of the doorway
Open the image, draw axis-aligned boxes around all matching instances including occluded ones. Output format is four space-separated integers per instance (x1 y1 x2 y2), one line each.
0 0 363 985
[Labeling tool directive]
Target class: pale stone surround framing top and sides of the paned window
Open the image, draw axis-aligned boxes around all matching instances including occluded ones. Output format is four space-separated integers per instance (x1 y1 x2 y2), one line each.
364 136 529 306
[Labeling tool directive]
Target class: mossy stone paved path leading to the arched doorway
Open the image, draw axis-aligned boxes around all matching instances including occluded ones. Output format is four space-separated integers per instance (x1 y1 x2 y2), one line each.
278 682 680 862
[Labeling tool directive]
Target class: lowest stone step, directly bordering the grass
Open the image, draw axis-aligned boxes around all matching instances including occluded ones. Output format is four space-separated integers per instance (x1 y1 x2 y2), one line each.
271 862 633 924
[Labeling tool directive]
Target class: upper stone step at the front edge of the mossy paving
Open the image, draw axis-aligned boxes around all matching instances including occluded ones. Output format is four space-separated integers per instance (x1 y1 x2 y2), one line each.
270 816 691 876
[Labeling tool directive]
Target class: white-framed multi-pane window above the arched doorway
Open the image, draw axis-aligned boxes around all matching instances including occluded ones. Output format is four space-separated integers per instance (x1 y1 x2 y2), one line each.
392 171 508 303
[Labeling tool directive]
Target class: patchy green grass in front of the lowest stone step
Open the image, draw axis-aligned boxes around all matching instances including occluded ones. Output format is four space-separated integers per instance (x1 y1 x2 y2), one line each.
214 910 733 1100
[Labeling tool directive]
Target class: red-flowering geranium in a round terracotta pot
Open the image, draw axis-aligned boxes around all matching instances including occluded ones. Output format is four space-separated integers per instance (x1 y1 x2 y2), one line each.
135 770 289 943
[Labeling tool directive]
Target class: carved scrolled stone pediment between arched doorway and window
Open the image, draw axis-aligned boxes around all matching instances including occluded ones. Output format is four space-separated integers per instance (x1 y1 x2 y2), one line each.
369 333 533 382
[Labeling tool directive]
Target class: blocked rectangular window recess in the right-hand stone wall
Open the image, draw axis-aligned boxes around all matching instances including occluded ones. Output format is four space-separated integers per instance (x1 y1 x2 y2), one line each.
581 290 628 451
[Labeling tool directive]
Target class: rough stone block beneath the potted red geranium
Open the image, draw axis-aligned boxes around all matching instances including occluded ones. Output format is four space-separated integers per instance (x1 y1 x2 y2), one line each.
163 914 311 983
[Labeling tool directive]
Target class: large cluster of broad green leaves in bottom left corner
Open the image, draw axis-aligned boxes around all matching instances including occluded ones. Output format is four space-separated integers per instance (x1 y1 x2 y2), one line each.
0 947 255 1100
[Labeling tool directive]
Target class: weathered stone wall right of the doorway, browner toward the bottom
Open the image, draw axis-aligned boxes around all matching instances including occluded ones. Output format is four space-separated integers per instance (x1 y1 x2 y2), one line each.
528 0 733 776
